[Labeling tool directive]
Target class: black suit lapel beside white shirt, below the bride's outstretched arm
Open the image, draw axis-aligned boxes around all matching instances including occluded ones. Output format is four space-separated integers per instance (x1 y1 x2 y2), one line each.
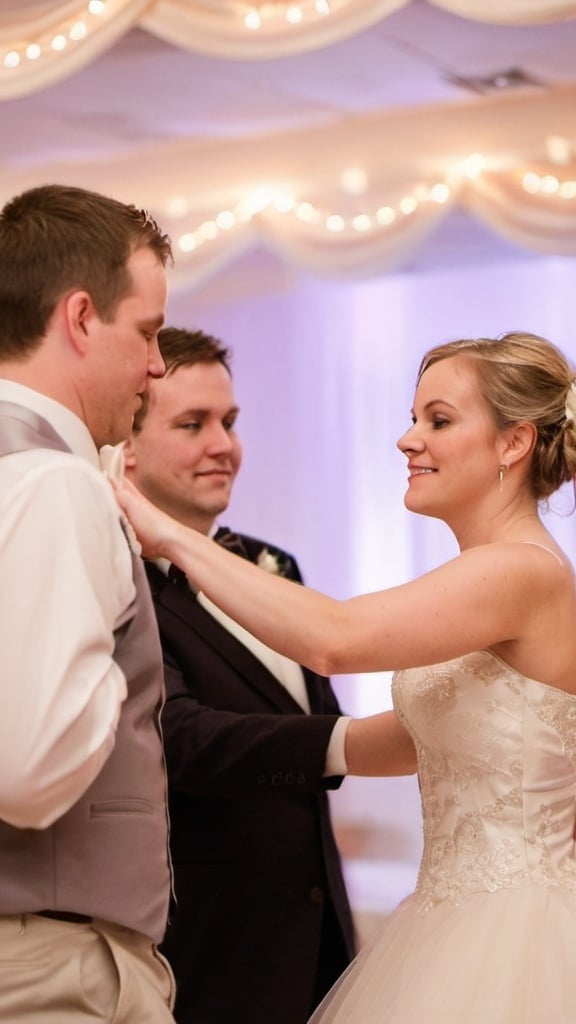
147 562 310 715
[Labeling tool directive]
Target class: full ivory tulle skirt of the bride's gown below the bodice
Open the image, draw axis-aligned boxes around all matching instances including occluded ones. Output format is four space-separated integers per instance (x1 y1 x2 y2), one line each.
310 887 576 1024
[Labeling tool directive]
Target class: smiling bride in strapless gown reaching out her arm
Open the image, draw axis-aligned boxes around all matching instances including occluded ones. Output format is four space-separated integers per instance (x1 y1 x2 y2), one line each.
117 333 576 1024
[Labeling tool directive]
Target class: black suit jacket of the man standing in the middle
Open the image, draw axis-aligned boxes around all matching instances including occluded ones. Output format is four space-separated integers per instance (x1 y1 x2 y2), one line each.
147 538 354 1024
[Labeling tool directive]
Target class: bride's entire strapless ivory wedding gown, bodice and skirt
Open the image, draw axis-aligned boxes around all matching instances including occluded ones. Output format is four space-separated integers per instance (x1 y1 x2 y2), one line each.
311 651 576 1024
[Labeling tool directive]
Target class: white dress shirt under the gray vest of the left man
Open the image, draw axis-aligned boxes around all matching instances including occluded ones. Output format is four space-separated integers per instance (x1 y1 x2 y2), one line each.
0 380 131 828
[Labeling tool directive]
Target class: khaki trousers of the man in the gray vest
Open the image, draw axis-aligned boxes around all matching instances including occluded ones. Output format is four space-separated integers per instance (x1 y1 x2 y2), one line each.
0 913 174 1024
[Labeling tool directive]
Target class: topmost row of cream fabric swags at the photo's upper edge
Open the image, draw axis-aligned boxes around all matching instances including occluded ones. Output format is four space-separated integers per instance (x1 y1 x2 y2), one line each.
0 0 576 99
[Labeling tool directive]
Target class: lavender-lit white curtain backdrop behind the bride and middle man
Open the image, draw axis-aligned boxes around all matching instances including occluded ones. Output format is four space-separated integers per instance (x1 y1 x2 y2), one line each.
169 258 576 910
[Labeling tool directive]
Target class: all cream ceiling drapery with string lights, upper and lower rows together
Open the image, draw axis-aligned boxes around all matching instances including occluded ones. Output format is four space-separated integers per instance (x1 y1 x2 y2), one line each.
0 0 576 285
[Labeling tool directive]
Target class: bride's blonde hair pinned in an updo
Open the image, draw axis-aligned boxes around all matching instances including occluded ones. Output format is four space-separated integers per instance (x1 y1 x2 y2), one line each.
418 332 576 500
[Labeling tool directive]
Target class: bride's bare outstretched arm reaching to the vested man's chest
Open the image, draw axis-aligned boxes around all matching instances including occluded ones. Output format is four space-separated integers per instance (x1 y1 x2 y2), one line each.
112 483 545 675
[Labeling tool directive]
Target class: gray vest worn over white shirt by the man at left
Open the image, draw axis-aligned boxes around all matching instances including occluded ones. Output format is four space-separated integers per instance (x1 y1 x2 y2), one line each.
0 401 170 942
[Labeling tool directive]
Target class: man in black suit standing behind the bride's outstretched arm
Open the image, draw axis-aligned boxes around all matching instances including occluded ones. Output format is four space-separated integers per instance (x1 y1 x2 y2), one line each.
125 328 354 1024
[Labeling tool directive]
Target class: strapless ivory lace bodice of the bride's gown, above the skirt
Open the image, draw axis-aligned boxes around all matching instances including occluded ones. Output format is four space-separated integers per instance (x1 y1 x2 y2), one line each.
393 651 576 910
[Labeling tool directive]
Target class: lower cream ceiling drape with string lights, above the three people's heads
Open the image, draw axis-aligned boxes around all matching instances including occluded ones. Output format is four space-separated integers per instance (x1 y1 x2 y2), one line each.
0 78 576 288
